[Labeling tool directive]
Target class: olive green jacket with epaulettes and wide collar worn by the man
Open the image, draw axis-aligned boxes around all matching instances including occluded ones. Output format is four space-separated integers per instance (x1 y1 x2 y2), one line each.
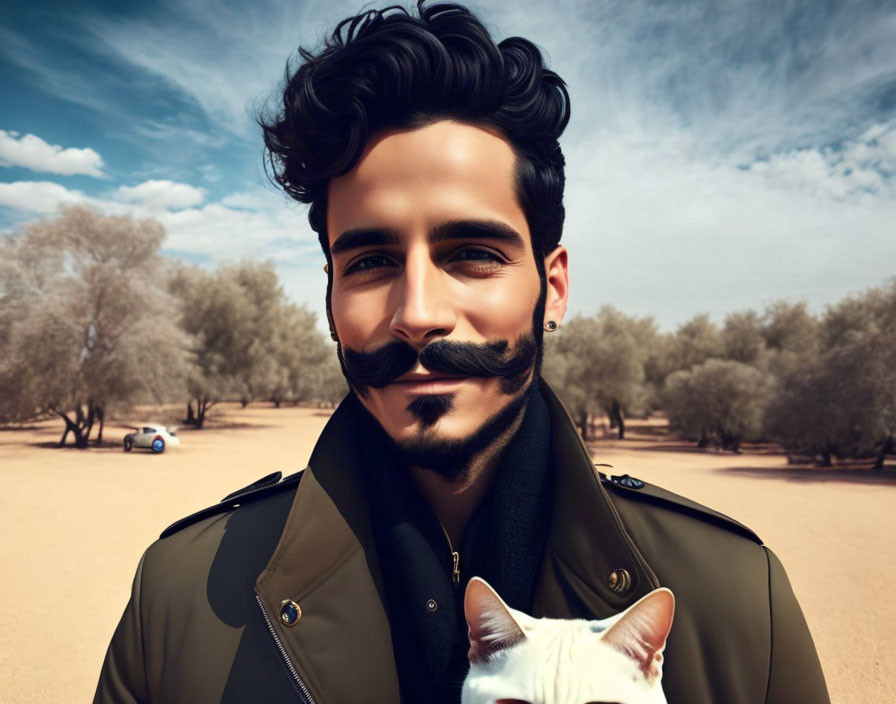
95 384 829 704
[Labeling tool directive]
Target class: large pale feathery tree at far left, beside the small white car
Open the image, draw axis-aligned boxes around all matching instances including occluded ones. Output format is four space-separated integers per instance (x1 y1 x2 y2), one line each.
0 206 189 448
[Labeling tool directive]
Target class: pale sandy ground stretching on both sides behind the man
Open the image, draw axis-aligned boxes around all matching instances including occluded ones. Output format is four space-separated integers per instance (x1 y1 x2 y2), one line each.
0 407 896 704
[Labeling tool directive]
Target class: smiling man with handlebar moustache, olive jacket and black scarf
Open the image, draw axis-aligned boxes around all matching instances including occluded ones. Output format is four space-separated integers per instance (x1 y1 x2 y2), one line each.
96 3 827 704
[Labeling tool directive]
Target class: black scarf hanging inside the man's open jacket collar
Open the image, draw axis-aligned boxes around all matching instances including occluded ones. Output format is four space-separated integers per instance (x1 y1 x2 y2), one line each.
361 384 552 704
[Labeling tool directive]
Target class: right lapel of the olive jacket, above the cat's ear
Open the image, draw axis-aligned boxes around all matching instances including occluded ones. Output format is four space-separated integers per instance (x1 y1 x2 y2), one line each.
534 382 659 619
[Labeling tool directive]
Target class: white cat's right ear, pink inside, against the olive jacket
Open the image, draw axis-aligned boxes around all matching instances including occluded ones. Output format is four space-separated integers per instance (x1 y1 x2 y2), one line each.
602 587 675 680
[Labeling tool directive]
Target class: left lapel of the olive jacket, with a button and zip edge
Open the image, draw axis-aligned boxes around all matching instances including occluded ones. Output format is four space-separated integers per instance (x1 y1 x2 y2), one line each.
256 399 399 704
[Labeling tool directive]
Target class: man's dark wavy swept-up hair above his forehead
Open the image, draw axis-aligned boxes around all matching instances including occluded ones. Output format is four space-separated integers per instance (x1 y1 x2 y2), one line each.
259 0 569 264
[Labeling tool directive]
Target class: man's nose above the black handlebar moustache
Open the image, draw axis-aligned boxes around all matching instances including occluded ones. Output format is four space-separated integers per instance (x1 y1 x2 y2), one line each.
389 251 457 346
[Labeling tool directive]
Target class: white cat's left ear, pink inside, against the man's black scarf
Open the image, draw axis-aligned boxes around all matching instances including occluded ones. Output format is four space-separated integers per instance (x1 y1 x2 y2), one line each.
464 577 526 663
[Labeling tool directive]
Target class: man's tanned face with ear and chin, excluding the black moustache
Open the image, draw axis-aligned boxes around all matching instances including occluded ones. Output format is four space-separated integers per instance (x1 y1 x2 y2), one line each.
327 121 566 456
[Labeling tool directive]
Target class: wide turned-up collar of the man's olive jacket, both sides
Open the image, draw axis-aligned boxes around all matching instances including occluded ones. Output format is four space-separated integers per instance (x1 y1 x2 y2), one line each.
256 381 657 703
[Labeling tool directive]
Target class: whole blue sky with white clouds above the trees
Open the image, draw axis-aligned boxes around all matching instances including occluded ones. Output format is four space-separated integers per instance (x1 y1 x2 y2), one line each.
0 0 896 329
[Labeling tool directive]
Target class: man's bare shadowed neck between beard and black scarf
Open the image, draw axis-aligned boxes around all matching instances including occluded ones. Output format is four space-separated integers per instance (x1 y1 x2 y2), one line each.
411 410 525 547
